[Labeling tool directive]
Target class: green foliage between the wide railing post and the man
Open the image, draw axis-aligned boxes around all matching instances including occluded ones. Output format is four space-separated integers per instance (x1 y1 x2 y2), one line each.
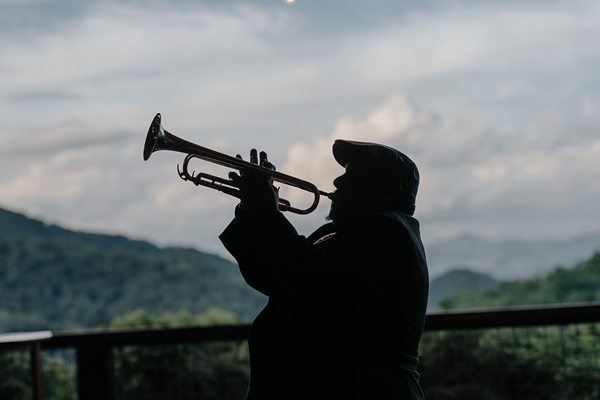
110 309 250 400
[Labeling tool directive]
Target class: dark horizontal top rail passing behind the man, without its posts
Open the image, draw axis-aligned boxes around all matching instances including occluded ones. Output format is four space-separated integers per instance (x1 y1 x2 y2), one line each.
35 302 600 348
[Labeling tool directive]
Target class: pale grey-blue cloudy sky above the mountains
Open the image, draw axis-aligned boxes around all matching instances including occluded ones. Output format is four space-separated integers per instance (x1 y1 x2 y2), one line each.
0 0 600 264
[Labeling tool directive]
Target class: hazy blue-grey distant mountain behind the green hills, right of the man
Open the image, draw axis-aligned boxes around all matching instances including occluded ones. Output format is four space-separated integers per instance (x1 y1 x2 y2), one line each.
427 233 600 280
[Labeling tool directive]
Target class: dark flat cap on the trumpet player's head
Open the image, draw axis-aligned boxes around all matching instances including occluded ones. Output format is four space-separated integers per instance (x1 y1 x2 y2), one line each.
333 139 419 215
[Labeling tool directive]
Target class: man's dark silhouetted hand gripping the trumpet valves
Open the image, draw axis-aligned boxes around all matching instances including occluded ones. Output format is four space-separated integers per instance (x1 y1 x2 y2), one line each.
229 149 279 218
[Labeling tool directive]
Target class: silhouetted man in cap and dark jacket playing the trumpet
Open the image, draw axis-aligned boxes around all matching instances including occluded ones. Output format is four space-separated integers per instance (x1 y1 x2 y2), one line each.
220 140 428 400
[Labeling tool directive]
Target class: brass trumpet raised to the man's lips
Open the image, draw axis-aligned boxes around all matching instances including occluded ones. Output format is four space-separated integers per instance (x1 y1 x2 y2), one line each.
144 114 331 214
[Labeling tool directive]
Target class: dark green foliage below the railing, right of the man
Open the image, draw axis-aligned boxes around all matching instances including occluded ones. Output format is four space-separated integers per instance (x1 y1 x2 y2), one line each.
421 325 600 400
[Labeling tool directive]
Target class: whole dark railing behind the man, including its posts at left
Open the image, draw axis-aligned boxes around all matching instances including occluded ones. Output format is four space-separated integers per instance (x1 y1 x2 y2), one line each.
0 302 600 400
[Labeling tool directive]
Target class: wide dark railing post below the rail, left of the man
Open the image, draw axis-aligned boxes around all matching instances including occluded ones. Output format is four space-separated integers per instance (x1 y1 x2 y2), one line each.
77 343 115 400
